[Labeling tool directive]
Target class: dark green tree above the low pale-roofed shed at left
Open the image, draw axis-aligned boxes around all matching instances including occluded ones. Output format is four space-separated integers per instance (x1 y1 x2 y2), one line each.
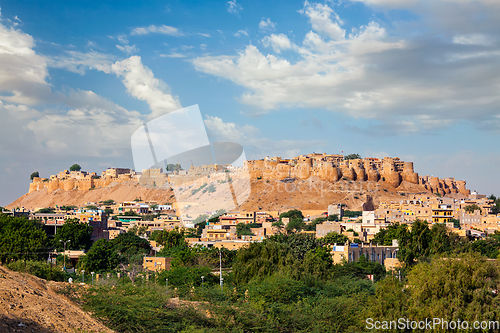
54 219 93 251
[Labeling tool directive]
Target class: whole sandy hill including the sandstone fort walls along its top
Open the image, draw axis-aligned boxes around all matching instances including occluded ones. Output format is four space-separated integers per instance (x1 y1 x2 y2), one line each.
7 154 470 211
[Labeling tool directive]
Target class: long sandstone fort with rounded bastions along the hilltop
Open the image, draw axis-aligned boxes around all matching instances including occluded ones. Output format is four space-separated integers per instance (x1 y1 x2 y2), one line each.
28 153 470 196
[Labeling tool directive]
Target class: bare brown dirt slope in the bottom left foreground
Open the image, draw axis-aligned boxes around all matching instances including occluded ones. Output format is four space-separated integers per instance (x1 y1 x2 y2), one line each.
0 266 113 333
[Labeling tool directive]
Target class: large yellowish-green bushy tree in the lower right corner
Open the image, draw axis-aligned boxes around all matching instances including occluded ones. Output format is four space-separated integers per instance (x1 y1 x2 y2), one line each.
372 253 500 324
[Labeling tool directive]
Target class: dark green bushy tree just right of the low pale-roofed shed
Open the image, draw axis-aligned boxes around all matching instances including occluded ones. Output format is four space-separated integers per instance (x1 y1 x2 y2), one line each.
78 239 119 272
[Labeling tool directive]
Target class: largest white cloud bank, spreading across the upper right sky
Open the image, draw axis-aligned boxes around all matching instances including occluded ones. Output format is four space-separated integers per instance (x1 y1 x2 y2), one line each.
193 0 500 133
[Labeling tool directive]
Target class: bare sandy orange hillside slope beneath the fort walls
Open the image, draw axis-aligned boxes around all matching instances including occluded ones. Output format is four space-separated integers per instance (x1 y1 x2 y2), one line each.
7 177 440 211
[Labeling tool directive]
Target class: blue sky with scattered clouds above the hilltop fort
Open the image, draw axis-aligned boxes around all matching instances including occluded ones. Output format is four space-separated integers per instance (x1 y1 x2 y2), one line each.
0 0 500 206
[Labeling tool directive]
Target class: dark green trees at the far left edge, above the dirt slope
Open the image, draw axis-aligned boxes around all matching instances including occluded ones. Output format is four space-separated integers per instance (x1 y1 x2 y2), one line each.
0 214 49 263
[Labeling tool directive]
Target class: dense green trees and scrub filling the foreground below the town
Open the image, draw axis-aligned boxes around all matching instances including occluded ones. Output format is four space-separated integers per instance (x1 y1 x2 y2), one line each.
4 211 500 333
